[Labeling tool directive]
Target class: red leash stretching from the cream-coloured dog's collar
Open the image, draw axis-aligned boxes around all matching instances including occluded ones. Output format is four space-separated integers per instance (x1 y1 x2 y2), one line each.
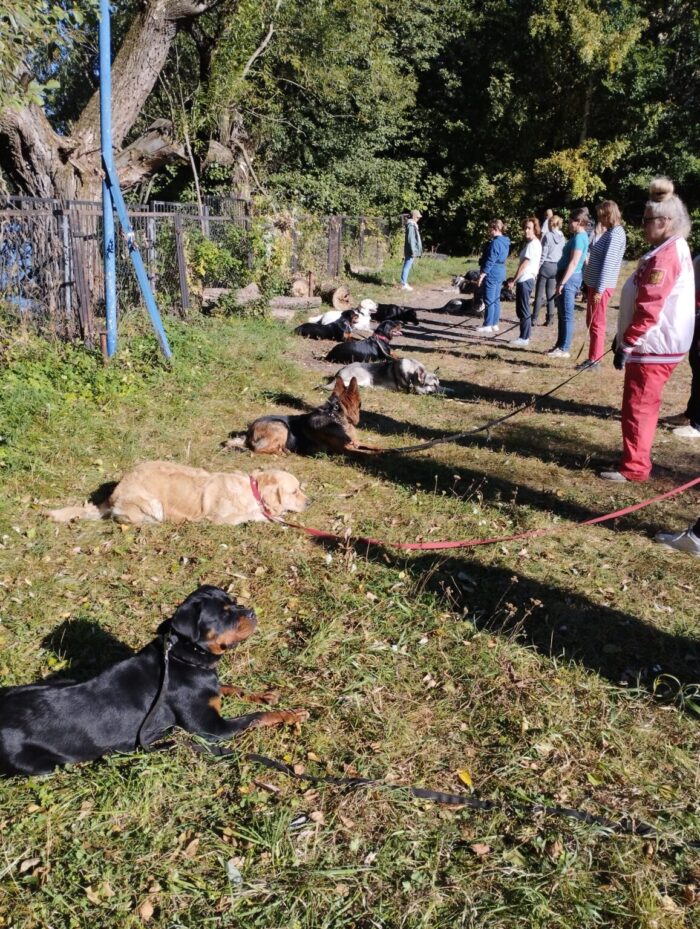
250 476 700 551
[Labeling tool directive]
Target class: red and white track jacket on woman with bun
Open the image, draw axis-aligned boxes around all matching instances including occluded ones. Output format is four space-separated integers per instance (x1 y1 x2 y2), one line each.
617 236 695 364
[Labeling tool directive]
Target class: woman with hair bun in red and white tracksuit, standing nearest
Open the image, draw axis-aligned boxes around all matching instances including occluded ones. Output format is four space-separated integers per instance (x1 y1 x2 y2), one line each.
600 177 695 481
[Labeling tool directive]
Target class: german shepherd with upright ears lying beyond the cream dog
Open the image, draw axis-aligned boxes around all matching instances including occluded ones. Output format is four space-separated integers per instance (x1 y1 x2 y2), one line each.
223 377 378 455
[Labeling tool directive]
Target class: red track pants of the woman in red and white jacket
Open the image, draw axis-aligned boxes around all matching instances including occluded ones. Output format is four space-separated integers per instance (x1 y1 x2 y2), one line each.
619 361 676 481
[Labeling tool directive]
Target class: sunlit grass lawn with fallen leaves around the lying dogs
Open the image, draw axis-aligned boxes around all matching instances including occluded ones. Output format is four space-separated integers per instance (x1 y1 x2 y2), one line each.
0 261 700 929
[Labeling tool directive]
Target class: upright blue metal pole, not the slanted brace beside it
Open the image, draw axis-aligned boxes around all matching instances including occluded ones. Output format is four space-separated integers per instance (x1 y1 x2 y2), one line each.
100 0 117 358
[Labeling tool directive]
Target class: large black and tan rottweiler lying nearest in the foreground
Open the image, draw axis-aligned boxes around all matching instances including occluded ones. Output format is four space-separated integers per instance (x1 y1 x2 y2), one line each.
0 585 308 775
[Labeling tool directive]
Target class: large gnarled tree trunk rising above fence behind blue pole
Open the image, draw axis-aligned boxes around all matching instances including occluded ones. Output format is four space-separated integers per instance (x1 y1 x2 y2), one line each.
0 0 227 199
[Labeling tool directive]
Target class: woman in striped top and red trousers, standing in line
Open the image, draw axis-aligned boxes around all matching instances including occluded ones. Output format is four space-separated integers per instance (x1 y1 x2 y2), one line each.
576 200 627 371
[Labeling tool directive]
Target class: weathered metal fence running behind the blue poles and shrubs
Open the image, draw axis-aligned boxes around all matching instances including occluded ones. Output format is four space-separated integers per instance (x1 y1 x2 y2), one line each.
0 196 402 345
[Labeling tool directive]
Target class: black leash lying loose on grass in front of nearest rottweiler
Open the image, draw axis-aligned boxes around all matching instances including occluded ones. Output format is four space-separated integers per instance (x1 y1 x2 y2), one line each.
175 742 700 849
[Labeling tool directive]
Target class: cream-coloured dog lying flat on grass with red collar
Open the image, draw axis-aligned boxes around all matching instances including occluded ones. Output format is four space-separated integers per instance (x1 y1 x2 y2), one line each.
47 461 309 526
